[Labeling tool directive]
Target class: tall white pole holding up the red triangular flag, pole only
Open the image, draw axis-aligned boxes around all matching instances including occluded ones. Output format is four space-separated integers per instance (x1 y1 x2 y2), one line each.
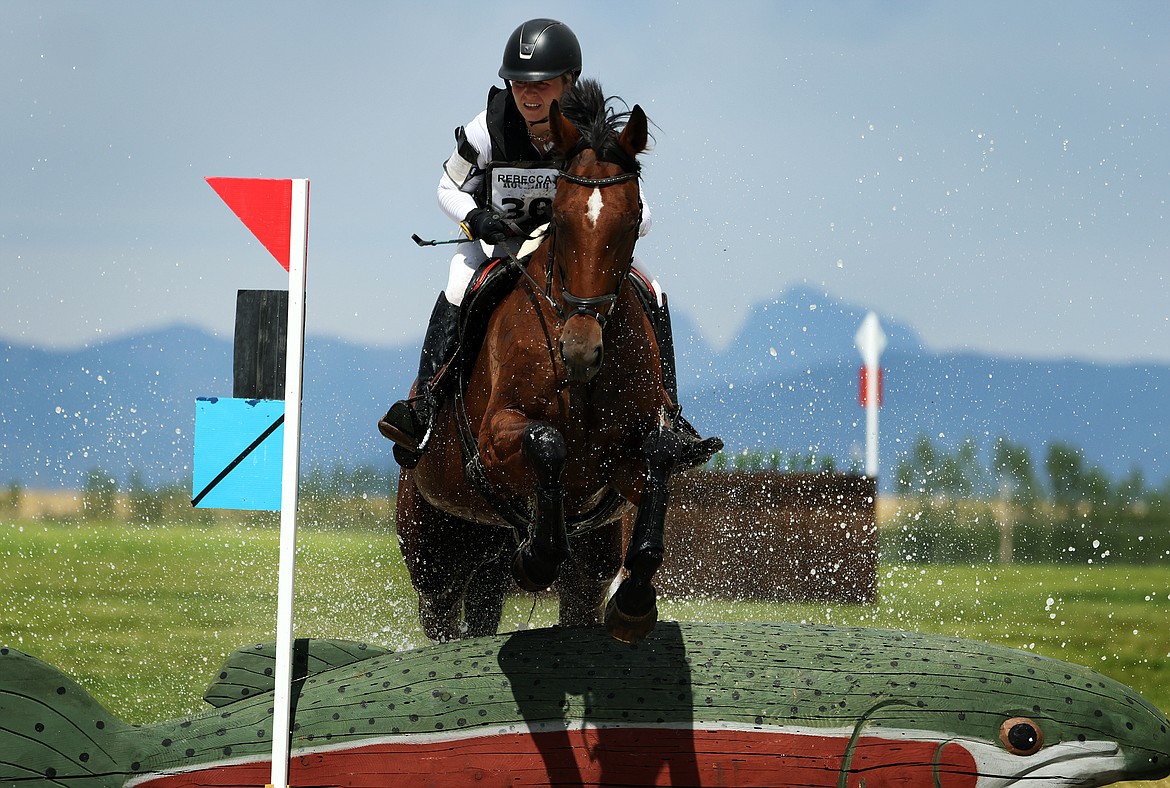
268 178 309 788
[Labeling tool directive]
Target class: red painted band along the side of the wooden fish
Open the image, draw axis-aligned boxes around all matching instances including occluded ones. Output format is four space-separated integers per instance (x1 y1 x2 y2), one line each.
138 728 977 788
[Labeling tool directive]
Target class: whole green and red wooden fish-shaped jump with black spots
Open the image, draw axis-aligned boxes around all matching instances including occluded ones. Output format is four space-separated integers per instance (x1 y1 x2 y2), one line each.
0 622 1170 788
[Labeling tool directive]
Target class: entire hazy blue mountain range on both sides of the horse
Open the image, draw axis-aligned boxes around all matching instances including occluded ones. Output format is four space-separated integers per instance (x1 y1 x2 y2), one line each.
0 288 1170 489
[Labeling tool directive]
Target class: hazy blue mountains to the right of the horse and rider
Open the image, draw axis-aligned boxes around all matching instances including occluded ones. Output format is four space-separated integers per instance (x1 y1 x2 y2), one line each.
680 288 1170 489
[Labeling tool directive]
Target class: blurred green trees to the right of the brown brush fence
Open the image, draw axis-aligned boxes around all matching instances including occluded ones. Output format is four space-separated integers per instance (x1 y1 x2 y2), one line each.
881 435 1170 565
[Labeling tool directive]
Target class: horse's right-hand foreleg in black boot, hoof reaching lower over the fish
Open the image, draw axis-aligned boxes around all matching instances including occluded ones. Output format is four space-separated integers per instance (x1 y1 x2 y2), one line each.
605 429 687 643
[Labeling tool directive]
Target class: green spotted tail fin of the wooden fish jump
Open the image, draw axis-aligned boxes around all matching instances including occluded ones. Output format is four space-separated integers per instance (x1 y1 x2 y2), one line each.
0 648 140 788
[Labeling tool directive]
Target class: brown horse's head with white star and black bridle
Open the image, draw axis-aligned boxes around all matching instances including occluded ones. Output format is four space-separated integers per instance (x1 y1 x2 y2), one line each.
549 81 648 382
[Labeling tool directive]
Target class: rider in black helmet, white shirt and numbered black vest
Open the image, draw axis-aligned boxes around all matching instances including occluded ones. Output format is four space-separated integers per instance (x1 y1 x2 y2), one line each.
378 19 697 461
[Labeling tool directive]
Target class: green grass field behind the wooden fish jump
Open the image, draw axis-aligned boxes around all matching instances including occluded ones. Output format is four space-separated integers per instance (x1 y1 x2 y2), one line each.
0 516 1170 787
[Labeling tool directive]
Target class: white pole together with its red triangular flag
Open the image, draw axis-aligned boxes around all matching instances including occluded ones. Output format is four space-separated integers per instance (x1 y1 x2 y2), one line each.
207 178 309 788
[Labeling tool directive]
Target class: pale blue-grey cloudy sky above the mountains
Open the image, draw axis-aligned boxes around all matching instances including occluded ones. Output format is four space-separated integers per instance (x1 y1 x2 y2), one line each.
0 0 1170 364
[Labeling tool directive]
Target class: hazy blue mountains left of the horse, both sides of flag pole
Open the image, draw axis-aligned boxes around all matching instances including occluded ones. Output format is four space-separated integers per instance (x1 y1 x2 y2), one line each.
0 326 418 489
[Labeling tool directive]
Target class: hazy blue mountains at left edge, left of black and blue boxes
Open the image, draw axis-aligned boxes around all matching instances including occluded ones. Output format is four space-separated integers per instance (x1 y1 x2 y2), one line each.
0 326 232 488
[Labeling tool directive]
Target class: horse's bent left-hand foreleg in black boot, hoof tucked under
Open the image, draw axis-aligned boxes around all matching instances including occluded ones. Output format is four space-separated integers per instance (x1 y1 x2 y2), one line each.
512 421 570 592
